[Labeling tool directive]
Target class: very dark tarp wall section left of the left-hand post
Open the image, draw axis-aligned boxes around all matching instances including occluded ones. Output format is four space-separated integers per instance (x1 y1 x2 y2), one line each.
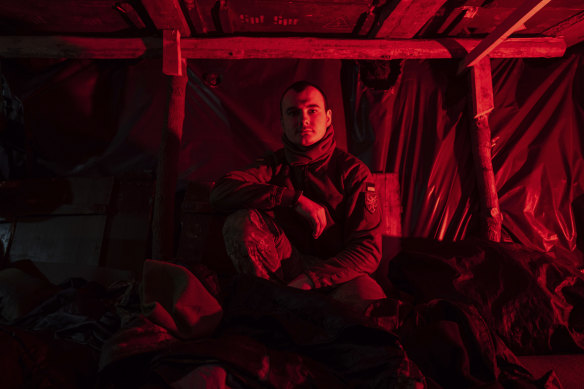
2 60 167 178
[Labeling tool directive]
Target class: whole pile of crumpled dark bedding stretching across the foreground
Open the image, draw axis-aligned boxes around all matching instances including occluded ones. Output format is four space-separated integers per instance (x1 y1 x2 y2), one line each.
0 239 584 388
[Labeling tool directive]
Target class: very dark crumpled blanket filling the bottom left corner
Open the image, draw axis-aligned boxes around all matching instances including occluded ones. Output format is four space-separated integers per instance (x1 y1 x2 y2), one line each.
0 270 127 389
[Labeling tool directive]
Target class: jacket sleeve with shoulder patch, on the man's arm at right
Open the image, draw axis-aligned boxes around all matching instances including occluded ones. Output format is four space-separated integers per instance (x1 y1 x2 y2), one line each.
305 165 381 288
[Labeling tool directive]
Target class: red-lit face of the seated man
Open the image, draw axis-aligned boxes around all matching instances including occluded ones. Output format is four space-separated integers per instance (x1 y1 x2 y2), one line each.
281 86 332 146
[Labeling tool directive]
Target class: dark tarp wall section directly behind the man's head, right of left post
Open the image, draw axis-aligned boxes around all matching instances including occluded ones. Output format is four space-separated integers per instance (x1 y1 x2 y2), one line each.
180 60 346 180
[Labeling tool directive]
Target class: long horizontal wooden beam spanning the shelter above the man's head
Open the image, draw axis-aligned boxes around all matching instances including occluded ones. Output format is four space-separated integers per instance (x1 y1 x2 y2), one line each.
0 36 566 60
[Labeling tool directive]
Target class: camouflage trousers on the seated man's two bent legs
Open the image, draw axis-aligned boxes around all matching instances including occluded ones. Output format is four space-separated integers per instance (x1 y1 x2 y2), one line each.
223 209 385 312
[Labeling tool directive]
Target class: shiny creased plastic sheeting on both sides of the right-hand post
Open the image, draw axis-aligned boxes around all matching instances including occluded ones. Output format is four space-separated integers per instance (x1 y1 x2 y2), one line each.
349 54 584 265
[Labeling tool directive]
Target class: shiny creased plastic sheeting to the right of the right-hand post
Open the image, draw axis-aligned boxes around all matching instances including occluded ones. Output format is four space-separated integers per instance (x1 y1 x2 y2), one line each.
491 55 584 263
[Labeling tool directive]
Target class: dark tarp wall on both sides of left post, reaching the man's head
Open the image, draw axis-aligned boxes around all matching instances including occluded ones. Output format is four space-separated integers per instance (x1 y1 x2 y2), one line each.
3 60 346 180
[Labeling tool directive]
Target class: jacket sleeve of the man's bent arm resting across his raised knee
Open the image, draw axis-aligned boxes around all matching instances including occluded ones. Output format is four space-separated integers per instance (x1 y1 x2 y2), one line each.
210 160 298 212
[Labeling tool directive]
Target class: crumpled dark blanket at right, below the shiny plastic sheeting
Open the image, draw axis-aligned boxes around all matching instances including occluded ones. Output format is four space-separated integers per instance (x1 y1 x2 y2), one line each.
388 239 584 355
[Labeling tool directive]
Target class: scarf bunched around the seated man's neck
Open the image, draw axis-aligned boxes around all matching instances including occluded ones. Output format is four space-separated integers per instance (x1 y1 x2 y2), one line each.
282 125 337 166
